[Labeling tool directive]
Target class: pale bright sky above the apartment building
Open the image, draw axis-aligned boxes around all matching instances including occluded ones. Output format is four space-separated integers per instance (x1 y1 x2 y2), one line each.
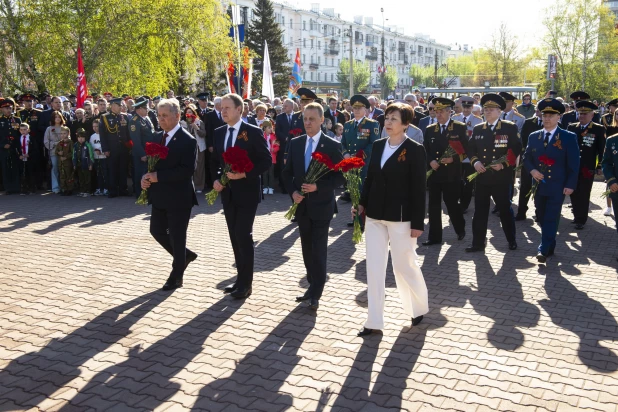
288 0 548 48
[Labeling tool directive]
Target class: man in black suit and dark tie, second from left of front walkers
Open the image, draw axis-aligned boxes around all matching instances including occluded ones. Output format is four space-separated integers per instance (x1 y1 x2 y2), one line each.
211 93 272 299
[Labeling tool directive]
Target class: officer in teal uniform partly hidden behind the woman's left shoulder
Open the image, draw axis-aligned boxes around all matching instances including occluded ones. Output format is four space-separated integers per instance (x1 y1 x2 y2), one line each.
341 94 380 226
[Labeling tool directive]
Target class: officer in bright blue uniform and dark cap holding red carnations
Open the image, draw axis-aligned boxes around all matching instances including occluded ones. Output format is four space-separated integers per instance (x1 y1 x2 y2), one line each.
524 98 579 263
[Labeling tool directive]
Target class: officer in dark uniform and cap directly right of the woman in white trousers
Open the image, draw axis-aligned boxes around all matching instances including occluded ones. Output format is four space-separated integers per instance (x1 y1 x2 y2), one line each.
423 97 468 246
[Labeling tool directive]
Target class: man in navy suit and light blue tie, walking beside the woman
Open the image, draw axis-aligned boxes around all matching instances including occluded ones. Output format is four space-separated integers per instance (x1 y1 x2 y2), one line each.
283 103 345 310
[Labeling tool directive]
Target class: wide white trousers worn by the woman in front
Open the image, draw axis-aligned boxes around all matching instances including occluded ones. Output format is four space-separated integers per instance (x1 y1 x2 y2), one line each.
365 217 429 329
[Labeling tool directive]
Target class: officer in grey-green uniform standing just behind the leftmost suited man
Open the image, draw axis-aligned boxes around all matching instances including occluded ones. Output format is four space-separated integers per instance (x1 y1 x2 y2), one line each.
129 96 157 197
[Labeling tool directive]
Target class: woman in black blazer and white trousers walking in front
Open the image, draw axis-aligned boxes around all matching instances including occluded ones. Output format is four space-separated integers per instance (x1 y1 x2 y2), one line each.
352 103 429 336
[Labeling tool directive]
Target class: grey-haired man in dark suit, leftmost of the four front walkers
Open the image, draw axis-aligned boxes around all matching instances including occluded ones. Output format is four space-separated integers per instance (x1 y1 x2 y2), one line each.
141 99 197 290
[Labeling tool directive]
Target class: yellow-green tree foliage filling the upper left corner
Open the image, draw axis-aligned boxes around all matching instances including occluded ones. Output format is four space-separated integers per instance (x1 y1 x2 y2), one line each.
0 0 231 94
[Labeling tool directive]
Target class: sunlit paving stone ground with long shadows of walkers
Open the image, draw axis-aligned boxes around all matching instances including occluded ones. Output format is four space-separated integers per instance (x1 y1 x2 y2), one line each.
0 183 618 412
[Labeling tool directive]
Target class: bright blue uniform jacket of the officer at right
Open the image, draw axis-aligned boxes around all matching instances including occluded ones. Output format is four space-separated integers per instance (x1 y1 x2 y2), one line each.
524 127 579 196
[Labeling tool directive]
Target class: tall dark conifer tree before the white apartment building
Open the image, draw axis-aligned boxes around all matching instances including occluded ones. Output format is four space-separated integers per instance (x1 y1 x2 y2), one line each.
245 0 292 96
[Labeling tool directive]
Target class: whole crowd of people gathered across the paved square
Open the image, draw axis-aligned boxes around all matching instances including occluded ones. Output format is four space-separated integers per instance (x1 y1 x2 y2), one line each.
0 88 618 335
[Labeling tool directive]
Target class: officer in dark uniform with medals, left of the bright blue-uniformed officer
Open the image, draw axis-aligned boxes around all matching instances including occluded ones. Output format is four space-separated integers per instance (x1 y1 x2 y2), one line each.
466 93 522 252
